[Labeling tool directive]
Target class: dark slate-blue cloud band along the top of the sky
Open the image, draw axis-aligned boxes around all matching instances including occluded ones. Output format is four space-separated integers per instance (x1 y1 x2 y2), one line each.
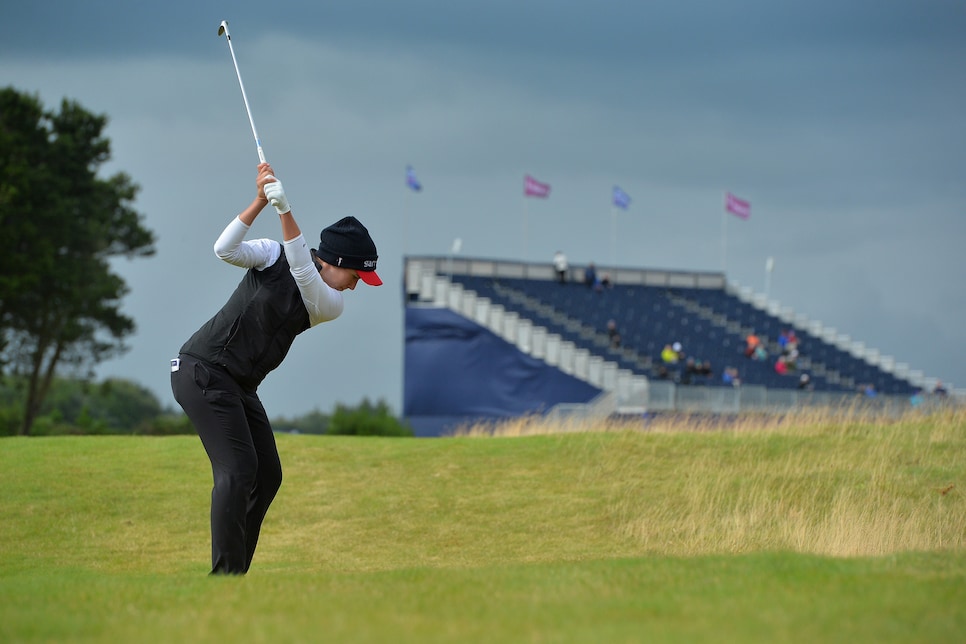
9 0 966 65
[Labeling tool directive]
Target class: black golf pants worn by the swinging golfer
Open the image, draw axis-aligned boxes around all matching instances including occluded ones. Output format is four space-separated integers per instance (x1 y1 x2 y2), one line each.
171 355 282 574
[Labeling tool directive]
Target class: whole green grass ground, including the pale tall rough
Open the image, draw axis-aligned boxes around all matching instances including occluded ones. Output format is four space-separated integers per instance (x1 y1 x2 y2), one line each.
0 412 966 643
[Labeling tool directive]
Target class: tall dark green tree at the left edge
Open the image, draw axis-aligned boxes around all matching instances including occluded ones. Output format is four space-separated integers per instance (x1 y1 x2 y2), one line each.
0 87 154 434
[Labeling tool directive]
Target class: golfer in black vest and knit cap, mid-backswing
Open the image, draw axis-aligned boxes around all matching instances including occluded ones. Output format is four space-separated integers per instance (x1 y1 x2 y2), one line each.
171 163 382 574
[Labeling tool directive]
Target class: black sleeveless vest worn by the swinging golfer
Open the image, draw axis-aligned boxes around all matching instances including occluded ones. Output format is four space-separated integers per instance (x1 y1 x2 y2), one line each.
181 253 309 391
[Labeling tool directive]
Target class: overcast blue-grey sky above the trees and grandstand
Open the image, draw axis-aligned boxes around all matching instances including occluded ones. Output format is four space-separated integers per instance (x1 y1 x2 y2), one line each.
0 0 966 416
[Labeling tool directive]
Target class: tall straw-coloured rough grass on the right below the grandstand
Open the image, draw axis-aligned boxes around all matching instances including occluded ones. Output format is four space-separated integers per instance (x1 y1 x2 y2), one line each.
458 408 966 557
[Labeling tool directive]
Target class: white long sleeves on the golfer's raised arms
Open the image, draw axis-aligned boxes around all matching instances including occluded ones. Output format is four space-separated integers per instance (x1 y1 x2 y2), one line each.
214 217 343 326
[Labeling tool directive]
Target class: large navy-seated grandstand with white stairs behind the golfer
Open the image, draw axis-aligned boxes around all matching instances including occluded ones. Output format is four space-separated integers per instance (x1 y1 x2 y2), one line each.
403 257 948 435
